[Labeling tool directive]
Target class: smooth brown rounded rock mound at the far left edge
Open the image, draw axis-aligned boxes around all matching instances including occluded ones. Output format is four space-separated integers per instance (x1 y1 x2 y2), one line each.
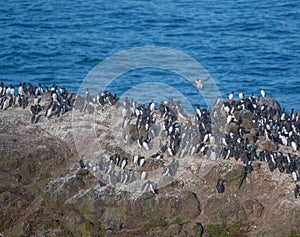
0 112 73 236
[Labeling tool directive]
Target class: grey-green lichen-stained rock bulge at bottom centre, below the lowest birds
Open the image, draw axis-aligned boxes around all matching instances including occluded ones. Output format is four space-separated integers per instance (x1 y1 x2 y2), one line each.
43 174 201 236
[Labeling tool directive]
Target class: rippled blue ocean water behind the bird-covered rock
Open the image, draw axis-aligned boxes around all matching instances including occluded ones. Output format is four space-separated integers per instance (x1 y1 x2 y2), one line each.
0 0 300 111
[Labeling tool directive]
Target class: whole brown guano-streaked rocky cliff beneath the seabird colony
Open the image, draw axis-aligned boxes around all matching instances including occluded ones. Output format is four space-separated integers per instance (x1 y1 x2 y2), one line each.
0 104 300 237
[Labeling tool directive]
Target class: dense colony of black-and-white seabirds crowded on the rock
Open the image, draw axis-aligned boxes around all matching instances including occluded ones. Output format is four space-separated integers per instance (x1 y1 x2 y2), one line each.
0 82 300 198
